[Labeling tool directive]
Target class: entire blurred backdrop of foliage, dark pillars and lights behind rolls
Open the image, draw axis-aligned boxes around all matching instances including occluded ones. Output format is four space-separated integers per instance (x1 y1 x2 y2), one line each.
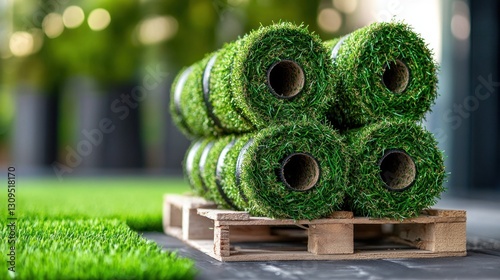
0 0 500 199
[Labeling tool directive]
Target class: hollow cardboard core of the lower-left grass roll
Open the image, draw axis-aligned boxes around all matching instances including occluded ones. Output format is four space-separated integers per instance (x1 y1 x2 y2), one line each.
280 153 320 191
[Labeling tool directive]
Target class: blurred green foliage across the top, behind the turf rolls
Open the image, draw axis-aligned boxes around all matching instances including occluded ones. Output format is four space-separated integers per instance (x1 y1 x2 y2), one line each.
9 0 322 88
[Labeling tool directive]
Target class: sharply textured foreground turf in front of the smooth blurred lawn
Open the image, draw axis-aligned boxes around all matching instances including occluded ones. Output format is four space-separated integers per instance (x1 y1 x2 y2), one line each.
0 219 195 279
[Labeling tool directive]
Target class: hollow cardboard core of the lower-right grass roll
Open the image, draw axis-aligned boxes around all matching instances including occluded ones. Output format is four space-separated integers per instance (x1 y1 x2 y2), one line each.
380 150 417 190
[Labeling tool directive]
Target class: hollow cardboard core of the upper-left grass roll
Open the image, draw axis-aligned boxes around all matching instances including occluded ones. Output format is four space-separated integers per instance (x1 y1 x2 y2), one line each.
267 60 305 98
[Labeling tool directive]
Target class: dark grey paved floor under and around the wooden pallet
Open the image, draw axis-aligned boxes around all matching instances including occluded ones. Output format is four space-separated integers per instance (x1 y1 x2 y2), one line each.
144 198 500 280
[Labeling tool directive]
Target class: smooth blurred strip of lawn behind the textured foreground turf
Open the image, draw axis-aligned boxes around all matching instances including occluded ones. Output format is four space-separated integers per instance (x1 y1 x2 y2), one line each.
7 177 189 231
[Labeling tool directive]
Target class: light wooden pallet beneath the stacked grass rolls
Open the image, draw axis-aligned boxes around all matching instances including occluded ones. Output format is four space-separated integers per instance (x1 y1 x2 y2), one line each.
163 195 467 261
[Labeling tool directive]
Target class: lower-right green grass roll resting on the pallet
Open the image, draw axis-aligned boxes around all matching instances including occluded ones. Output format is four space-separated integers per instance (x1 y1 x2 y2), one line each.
346 121 445 219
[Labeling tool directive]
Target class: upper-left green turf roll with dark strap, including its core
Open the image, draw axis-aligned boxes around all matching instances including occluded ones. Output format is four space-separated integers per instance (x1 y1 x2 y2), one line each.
171 23 334 137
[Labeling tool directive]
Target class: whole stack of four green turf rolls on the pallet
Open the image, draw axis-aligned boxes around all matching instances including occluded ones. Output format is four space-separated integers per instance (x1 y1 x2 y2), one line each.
170 22 445 219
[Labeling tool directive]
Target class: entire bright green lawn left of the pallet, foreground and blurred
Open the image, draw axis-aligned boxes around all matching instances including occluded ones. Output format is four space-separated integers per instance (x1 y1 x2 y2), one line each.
0 178 195 279
